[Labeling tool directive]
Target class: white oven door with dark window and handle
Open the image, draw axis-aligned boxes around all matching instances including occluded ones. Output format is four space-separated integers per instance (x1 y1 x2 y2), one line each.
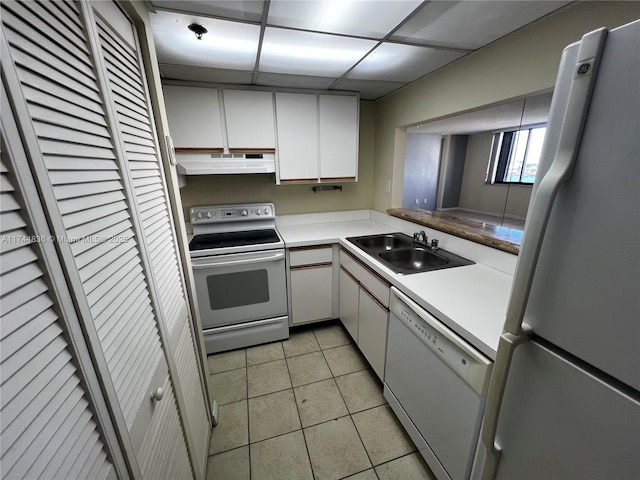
192 250 287 330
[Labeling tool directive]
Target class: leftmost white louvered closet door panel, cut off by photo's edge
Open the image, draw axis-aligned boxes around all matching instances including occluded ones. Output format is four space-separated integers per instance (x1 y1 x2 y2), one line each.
0 151 115 479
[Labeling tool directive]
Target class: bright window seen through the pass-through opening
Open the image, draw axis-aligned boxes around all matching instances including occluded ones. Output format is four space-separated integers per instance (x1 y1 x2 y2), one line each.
487 126 547 184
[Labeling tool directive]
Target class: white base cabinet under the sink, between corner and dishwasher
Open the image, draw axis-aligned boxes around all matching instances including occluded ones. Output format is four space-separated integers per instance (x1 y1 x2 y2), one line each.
340 250 391 380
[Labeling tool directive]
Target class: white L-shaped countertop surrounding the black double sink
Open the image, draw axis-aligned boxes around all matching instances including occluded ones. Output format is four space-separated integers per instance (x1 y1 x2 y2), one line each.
277 214 512 360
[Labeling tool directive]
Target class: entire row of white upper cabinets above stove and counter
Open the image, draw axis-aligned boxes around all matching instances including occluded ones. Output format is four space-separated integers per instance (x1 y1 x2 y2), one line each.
163 85 359 183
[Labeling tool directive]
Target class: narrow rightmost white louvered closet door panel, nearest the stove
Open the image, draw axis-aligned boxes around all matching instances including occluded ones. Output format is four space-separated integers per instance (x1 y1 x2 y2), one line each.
95 2 210 472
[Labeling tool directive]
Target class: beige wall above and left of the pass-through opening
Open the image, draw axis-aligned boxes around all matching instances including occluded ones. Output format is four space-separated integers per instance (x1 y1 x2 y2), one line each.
372 1 640 211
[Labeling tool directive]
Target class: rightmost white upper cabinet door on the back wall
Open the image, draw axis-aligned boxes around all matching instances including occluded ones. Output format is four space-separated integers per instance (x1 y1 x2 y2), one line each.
318 95 358 180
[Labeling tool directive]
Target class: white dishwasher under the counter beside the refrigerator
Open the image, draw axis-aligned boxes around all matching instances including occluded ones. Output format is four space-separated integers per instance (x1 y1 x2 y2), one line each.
384 287 493 480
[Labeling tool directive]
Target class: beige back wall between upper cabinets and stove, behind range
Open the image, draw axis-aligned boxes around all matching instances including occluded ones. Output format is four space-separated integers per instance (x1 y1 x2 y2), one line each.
176 101 375 218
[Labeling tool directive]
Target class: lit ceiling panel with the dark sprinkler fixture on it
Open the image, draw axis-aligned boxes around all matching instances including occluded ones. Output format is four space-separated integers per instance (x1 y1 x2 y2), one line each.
151 12 260 70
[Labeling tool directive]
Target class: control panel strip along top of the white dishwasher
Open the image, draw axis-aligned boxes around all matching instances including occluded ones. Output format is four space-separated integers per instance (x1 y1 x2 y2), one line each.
389 289 493 395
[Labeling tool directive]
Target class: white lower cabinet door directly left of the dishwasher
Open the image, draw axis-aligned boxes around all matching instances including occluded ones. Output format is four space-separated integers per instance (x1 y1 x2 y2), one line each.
358 288 389 380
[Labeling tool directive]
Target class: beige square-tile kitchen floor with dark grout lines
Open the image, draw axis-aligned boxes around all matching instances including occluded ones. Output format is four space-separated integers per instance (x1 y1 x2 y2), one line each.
207 322 435 480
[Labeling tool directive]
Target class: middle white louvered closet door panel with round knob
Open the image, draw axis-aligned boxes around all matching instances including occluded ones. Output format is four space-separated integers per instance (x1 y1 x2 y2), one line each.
2 1 193 478
